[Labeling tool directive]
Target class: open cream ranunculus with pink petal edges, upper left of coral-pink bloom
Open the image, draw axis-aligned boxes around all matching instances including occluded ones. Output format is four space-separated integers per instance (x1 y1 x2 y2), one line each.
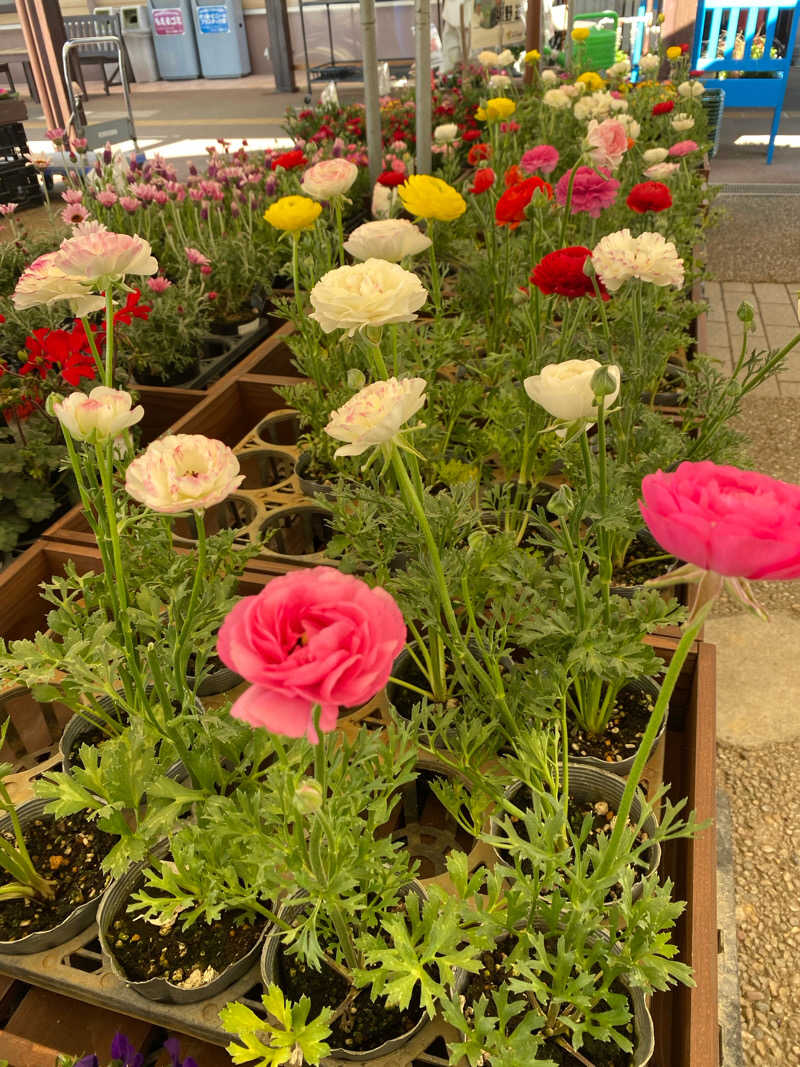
125 433 244 515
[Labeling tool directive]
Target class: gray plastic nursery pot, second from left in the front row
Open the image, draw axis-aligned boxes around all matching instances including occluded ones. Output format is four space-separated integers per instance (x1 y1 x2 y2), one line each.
97 841 261 1004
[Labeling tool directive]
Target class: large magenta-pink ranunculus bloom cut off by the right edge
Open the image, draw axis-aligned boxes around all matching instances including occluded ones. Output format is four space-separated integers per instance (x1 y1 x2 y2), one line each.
639 460 800 580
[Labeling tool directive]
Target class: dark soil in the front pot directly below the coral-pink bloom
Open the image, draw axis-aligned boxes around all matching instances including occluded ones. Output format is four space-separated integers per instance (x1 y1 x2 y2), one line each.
277 949 420 1052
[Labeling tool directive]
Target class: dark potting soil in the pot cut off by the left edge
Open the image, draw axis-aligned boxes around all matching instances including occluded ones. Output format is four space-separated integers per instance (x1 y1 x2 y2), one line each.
0 814 116 941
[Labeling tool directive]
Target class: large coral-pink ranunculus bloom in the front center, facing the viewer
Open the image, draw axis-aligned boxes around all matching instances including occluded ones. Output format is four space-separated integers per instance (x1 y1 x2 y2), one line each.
217 567 405 742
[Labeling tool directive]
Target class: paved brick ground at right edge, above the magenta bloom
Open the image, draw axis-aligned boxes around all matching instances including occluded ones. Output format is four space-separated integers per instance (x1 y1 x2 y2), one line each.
705 282 800 397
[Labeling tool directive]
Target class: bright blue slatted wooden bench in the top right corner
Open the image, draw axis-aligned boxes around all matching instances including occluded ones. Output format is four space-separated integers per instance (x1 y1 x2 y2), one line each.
691 0 800 163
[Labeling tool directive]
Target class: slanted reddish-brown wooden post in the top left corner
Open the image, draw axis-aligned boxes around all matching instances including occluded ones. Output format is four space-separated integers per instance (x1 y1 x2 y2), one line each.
16 0 69 129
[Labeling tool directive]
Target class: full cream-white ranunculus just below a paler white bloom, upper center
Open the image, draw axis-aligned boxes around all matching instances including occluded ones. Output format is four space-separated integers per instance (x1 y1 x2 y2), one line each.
309 259 428 337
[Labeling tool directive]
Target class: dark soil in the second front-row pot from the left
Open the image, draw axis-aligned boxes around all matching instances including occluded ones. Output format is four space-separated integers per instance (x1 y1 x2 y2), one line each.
108 882 266 989
